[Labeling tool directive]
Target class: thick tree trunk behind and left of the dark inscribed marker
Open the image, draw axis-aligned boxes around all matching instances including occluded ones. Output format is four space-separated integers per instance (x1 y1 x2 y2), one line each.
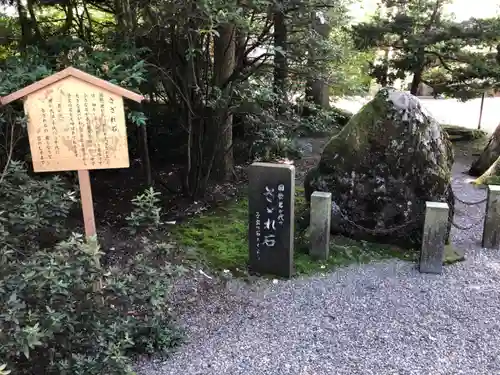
211 24 236 181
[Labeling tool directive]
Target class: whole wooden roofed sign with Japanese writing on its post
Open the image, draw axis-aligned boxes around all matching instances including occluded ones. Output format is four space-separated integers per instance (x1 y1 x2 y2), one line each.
0 67 144 237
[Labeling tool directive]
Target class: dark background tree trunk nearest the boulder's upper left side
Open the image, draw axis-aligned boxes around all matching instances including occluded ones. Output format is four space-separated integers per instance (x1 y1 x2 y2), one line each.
305 13 331 109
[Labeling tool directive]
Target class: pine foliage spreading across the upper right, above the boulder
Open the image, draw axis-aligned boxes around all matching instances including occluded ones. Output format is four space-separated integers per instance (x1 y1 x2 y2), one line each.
353 0 500 97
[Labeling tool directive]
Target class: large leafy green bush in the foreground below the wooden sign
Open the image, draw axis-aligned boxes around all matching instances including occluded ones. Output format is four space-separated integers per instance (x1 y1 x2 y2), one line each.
0 235 184 375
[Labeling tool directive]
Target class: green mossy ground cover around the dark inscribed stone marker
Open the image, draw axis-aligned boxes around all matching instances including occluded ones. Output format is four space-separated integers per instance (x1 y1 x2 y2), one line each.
173 189 416 275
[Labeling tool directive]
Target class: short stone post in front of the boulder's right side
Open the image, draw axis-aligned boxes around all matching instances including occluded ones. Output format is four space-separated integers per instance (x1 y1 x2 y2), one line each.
420 202 450 274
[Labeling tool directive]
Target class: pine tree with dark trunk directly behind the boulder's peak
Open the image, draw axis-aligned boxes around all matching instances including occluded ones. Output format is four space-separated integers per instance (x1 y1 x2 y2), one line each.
353 0 454 94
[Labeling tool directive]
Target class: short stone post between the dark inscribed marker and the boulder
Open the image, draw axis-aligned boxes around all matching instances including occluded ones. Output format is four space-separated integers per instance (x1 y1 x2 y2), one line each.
309 191 332 260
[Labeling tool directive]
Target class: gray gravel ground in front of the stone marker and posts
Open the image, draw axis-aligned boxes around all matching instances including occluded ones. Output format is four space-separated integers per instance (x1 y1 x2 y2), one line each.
138 159 500 375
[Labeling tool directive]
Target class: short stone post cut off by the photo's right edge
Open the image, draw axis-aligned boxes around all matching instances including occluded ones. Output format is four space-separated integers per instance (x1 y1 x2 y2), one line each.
482 185 500 249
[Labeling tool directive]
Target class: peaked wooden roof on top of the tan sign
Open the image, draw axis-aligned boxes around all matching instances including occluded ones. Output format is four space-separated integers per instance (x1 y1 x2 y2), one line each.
0 67 144 105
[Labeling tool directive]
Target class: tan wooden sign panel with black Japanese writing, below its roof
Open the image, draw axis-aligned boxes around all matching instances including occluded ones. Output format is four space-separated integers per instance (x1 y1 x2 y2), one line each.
24 76 129 172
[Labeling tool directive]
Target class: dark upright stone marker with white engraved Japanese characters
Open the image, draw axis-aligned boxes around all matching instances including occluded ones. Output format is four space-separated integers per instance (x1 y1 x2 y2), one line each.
248 163 295 277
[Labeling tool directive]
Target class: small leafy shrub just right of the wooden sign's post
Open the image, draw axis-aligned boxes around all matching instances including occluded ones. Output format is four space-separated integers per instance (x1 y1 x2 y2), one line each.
126 187 161 234
